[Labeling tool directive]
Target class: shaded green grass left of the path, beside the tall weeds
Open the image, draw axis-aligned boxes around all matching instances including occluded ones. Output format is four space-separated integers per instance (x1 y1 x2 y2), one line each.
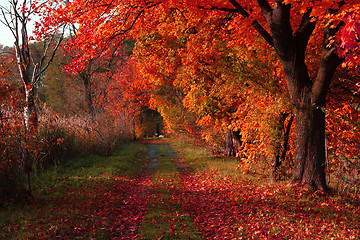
0 142 147 239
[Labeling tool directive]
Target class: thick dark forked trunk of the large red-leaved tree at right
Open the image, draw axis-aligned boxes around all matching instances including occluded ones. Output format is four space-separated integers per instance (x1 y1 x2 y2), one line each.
257 0 341 191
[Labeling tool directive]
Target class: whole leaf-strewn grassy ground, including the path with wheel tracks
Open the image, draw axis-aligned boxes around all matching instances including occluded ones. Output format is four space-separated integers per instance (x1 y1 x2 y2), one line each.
0 138 360 239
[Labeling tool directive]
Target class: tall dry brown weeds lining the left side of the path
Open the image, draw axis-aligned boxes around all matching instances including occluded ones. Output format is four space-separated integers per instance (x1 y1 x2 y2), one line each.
0 107 133 207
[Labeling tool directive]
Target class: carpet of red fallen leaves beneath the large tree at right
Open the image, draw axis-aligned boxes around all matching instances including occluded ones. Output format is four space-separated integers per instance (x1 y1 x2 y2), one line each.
175 174 360 239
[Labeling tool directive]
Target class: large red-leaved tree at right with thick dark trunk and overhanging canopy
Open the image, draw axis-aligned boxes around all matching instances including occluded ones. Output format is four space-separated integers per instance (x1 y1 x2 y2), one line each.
43 0 359 191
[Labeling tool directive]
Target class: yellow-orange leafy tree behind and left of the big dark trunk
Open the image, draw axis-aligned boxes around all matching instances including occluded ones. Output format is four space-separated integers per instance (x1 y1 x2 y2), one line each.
135 5 293 176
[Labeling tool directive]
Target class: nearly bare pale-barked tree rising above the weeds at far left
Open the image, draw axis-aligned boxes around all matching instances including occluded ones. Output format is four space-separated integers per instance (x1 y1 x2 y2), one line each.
1 0 62 129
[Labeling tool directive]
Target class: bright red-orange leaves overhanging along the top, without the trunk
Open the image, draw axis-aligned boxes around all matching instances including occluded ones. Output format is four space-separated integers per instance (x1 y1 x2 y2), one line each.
37 0 360 67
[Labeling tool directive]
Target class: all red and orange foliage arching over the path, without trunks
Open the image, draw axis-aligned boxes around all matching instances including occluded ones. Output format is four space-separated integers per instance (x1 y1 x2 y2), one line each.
40 0 360 181
